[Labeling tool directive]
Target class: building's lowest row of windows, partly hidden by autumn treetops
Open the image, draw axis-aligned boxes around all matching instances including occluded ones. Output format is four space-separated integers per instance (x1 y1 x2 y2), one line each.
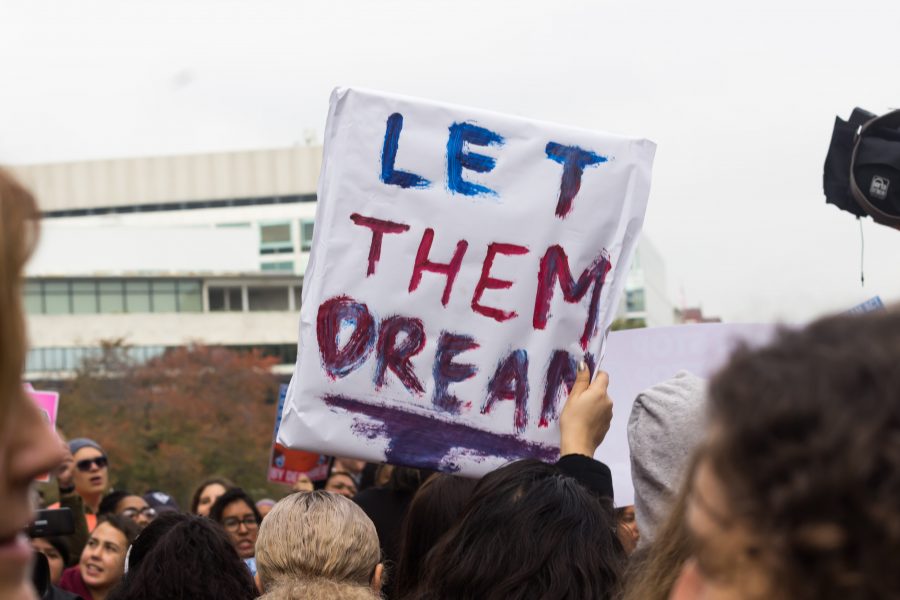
25 344 297 373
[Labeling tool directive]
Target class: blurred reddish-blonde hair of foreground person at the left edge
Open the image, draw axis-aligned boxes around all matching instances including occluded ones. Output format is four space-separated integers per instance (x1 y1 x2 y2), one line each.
0 168 40 425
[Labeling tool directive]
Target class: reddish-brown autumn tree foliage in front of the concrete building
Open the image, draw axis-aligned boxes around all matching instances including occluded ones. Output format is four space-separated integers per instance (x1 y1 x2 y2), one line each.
53 342 286 509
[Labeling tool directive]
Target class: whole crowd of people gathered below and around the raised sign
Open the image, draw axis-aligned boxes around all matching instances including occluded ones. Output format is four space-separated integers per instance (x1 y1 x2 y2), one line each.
0 165 900 600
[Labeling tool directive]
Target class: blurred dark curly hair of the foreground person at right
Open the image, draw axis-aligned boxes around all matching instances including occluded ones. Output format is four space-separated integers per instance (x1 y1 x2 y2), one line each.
702 312 900 600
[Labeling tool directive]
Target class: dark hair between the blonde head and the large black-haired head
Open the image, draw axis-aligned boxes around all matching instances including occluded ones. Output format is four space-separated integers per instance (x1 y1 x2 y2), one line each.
390 473 478 598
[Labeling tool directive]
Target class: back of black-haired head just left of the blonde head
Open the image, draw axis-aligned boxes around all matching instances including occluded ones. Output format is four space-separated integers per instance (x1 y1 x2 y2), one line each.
110 515 256 600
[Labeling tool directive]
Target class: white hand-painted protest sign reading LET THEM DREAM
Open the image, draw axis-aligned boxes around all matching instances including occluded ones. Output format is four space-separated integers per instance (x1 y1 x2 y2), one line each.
278 89 656 475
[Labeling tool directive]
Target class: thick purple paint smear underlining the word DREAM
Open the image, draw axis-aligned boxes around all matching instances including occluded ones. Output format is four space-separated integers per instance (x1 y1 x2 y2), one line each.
322 394 559 472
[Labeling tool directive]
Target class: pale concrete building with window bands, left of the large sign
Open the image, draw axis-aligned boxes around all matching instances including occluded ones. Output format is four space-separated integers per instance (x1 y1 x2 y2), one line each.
13 147 322 379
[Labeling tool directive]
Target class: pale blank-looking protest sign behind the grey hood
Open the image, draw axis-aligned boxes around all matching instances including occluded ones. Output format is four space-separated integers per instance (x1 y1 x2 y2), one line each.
595 323 775 506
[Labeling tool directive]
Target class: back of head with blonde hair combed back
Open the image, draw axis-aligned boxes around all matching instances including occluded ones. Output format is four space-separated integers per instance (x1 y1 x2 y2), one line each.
256 490 381 589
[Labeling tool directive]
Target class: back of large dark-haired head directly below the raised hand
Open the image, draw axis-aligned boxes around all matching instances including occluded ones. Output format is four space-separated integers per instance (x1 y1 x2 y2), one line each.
411 460 624 600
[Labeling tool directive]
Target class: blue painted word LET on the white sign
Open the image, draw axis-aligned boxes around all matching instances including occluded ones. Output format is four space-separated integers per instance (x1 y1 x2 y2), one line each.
381 113 608 218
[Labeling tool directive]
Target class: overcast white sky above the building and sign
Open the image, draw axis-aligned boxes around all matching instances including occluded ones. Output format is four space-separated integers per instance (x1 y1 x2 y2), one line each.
0 0 900 321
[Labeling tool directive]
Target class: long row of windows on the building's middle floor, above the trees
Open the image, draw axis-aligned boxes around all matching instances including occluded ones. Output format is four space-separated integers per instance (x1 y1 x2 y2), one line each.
25 279 301 315
